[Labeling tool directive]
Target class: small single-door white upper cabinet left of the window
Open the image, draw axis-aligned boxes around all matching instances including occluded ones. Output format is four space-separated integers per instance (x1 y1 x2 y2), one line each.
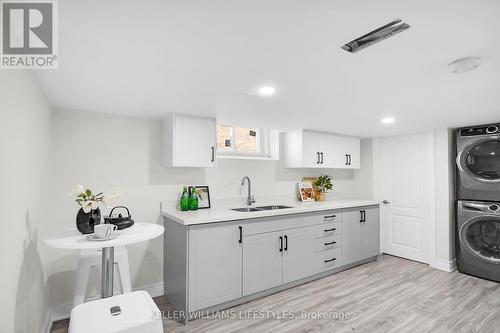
163 114 216 168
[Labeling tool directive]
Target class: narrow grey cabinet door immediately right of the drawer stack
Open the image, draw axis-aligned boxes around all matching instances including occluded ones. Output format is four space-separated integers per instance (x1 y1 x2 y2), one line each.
342 209 363 265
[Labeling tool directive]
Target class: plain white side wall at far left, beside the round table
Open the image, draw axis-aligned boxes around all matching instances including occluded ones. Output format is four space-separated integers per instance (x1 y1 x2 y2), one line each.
0 71 51 333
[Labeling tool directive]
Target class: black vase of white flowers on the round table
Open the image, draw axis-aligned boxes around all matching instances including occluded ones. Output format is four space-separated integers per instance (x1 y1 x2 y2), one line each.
71 185 119 234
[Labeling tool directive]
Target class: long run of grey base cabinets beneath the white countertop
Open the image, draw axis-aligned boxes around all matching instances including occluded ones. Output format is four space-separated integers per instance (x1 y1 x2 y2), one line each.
164 206 379 313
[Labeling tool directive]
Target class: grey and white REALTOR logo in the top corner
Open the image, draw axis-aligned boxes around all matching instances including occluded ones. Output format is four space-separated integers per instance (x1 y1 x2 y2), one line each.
1 0 57 69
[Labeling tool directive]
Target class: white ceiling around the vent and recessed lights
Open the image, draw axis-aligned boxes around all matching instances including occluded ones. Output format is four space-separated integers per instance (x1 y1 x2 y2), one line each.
37 0 500 137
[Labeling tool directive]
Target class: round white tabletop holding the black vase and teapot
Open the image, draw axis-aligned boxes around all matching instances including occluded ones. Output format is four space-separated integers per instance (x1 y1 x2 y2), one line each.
43 223 165 250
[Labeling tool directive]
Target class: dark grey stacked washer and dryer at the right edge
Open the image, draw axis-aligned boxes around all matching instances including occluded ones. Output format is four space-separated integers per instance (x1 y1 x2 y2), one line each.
456 124 500 282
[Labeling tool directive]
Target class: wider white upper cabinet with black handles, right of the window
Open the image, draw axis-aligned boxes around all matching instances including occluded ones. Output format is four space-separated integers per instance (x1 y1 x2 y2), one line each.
285 130 361 169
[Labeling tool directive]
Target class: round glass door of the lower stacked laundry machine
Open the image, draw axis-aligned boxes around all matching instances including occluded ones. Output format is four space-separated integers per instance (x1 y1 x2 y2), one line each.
460 216 500 264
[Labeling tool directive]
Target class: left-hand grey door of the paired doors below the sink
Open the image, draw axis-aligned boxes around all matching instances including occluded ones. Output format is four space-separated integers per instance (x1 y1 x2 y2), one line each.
243 231 283 296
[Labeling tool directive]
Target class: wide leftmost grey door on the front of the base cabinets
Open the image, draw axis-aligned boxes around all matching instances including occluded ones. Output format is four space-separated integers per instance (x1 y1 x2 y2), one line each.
189 225 242 311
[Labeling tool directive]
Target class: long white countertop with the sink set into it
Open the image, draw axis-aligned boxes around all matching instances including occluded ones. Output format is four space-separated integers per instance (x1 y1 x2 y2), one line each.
162 199 379 226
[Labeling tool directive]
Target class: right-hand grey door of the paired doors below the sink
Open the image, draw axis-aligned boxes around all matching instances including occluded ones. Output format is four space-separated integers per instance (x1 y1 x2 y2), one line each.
283 226 317 283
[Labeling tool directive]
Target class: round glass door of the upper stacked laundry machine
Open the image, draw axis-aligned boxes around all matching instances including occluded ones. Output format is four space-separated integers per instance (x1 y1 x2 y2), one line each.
461 139 500 182
